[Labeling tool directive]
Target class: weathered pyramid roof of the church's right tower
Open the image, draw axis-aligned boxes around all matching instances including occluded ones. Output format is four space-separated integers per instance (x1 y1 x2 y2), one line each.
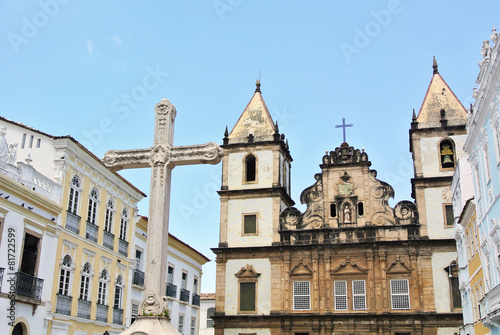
416 57 467 128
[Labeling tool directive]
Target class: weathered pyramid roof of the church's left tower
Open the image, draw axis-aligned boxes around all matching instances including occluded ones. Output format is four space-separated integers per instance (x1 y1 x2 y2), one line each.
228 79 276 144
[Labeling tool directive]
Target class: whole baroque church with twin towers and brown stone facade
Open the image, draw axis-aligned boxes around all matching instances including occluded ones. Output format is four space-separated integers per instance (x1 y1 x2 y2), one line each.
212 60 467 335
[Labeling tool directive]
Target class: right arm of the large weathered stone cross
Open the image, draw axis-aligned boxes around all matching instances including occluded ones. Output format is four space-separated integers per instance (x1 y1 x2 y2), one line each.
170 142 224 166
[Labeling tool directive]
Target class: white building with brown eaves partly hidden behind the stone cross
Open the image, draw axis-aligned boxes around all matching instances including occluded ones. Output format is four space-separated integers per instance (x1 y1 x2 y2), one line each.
130 216 209 335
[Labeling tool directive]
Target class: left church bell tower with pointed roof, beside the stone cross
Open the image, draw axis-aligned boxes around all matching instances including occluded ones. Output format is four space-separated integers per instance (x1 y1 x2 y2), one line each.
219 80 294 248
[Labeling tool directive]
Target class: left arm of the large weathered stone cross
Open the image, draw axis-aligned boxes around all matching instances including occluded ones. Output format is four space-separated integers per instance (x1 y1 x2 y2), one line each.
102 148 152 171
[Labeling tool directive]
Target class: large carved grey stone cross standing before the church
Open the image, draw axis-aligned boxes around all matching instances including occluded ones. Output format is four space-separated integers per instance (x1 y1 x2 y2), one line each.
102 99 223 316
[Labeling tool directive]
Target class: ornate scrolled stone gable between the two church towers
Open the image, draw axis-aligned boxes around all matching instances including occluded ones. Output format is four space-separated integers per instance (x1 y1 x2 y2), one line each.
280 144 420 244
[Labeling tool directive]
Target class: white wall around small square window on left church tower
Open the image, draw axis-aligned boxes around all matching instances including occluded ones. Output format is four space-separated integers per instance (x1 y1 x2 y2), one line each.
227 198 273 247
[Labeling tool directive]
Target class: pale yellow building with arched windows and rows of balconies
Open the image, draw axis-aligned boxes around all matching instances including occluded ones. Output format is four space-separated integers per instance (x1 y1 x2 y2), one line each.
48 137 145 335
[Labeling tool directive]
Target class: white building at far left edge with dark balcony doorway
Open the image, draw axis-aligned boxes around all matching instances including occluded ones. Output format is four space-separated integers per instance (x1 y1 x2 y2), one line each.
0 126 63 334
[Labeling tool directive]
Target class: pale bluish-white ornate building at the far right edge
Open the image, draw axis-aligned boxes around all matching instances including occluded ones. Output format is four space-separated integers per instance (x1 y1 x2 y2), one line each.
464 27 500 334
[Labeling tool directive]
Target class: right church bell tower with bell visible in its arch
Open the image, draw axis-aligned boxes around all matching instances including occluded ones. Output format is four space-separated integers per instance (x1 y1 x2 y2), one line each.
410 58 467 239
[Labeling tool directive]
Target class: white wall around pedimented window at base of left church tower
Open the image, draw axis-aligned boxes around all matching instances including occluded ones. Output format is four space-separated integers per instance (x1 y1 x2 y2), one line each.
225 258 271 316
